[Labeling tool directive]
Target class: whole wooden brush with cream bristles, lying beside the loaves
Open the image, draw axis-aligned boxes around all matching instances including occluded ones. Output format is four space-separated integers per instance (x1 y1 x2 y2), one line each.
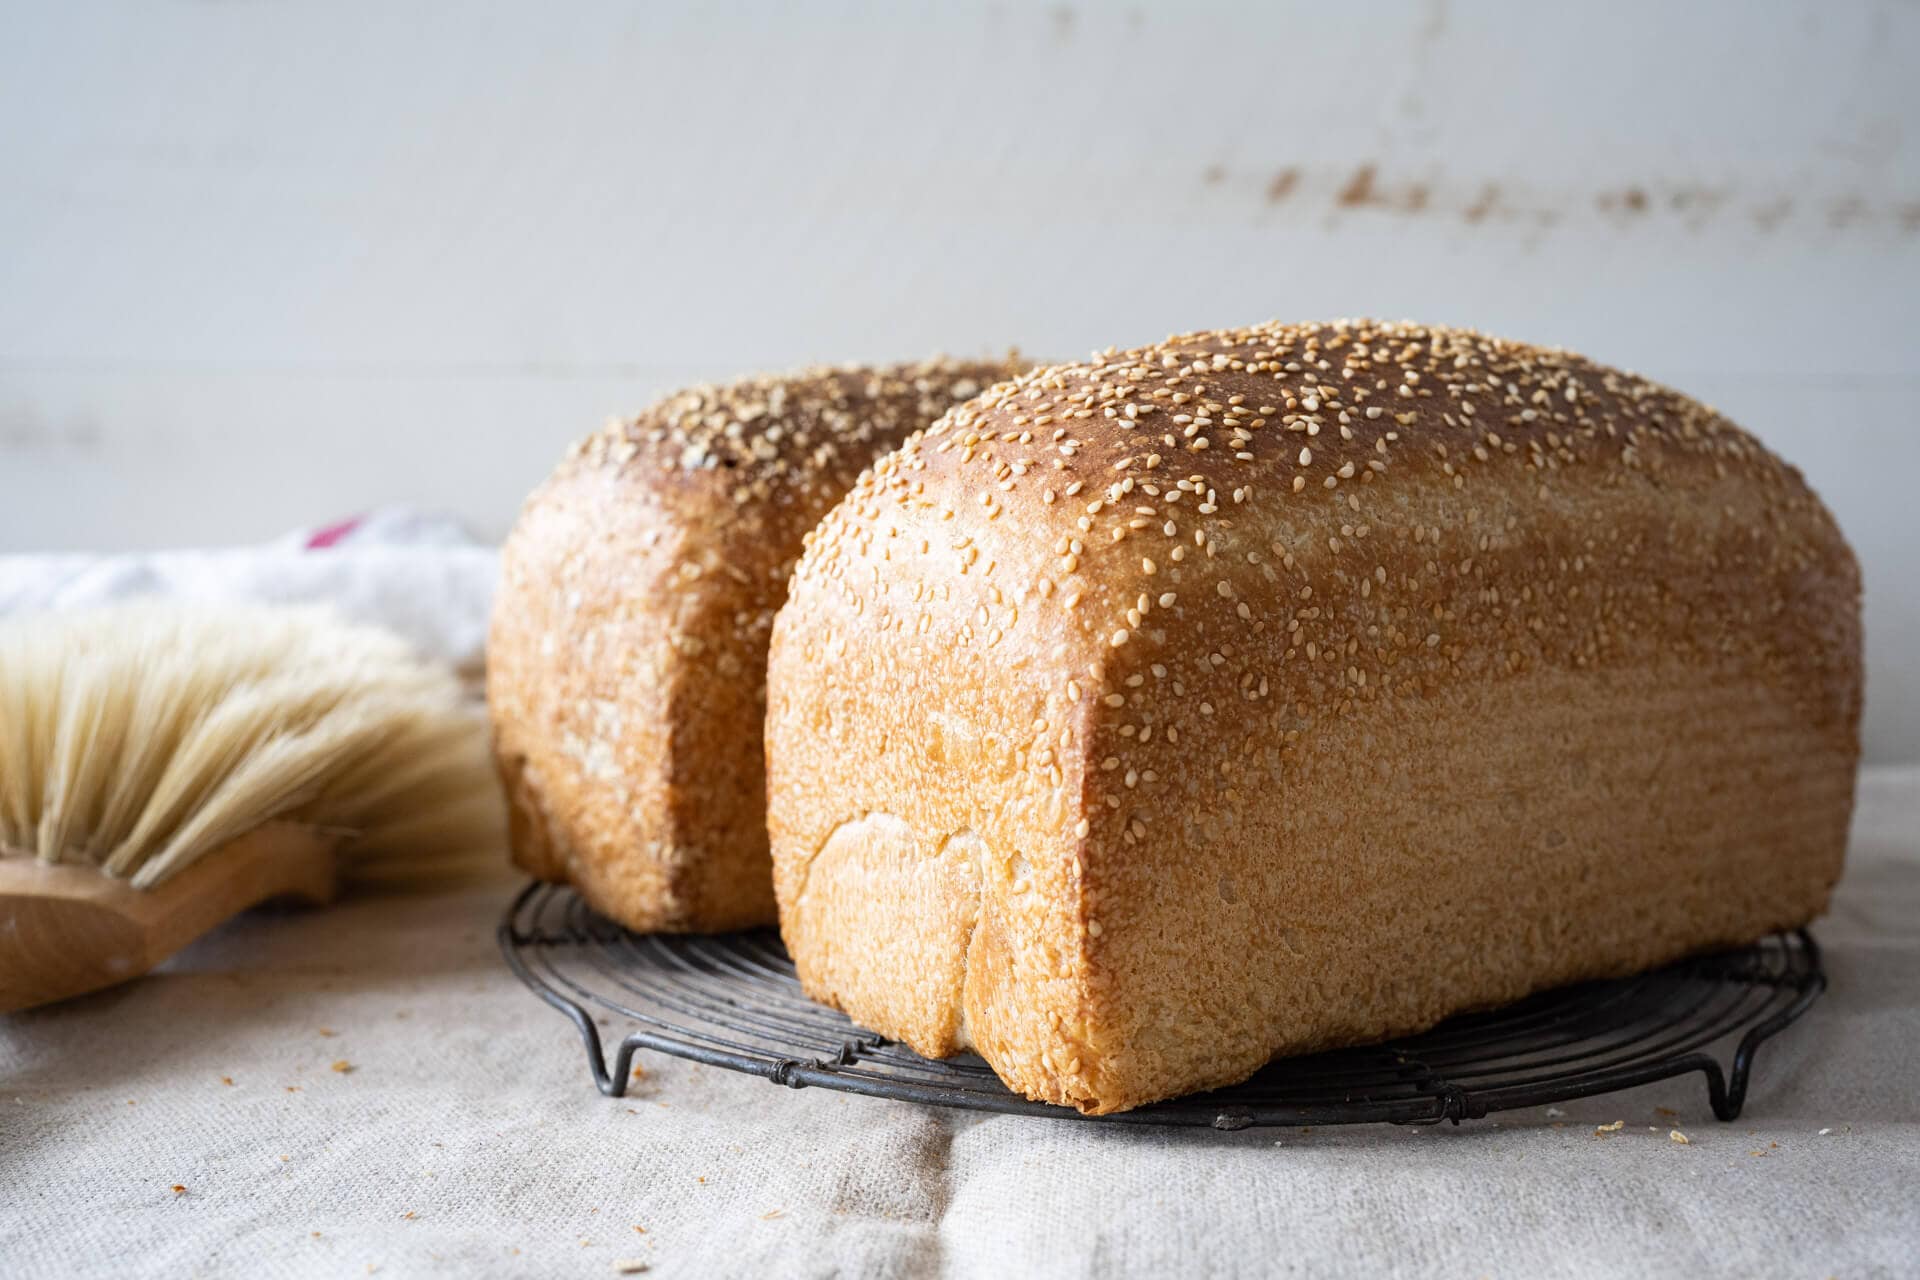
0 603 503 1011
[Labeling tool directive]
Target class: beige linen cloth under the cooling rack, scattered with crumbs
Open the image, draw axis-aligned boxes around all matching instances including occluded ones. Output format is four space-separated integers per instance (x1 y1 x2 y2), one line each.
0 770 1920 1276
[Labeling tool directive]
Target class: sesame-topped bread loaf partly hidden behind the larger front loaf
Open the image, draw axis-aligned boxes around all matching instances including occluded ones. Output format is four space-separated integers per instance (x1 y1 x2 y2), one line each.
488 361 1016 931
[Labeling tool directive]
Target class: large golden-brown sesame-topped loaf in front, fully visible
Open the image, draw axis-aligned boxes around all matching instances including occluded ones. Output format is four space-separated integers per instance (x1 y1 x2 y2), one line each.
766 320 1860 1113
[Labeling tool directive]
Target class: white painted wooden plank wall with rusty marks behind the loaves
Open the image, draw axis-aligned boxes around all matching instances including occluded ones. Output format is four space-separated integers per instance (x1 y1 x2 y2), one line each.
0 0 1920 756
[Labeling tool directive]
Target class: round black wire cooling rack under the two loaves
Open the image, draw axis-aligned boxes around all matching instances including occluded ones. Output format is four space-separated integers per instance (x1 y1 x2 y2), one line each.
499 885 1826 1128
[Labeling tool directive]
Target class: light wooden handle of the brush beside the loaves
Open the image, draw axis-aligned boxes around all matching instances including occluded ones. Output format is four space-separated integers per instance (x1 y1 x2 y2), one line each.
0 823 334 1013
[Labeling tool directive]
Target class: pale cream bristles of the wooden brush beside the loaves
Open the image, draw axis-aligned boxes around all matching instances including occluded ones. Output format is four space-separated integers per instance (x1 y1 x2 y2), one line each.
0 603 505 889
